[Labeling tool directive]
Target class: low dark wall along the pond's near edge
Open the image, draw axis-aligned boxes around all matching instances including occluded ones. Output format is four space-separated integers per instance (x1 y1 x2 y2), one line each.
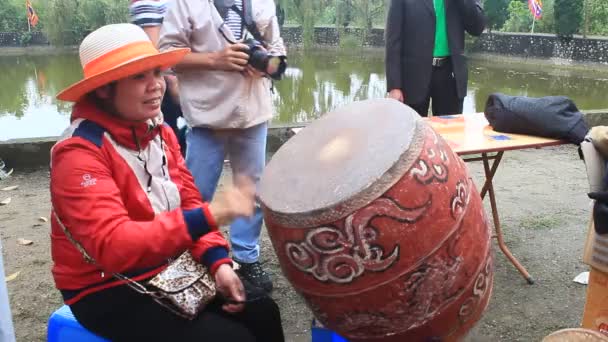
0 109 608 169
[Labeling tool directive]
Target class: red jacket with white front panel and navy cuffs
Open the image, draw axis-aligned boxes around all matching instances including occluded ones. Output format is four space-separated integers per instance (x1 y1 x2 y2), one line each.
51 102 230 304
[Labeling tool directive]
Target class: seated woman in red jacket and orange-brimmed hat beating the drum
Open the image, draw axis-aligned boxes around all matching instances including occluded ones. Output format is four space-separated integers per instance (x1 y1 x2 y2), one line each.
51 24 283 341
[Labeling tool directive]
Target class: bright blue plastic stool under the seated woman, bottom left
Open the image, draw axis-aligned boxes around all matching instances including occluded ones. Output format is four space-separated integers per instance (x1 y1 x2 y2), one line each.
47 305 110 342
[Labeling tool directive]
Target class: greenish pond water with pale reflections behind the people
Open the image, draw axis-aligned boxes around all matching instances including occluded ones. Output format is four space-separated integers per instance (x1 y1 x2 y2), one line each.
0 49 608 141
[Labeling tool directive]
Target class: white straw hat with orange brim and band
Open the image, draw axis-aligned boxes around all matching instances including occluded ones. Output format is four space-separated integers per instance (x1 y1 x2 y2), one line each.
57 24 190 102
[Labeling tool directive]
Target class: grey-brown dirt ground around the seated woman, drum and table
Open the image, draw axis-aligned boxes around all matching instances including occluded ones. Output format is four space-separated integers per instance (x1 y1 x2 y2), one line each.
0 146 589 342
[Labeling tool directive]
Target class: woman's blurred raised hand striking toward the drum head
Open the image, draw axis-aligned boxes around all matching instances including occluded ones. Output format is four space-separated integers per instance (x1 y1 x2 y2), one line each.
209 176 255 227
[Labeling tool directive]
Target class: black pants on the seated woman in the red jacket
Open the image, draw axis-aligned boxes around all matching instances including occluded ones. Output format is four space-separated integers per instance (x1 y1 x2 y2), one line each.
70 286 284 342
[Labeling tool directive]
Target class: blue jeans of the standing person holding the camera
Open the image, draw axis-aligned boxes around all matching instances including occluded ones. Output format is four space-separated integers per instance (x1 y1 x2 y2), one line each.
186 123 268 263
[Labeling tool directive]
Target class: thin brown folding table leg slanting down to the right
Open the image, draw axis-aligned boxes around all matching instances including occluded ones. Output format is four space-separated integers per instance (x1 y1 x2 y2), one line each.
482 152 534 285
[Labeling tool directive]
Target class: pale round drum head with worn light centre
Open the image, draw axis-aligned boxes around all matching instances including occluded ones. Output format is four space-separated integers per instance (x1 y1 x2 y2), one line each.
259 99 421 222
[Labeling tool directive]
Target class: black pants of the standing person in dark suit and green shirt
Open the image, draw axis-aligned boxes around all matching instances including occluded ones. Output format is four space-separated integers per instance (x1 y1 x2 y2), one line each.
405 59 464 116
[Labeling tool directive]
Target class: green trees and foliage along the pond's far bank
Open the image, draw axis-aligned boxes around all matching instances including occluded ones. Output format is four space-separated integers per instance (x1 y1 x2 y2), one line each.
0 0 608 47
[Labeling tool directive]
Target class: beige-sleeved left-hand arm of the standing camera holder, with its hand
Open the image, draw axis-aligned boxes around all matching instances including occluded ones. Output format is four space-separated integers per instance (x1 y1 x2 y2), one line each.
159 0 249 72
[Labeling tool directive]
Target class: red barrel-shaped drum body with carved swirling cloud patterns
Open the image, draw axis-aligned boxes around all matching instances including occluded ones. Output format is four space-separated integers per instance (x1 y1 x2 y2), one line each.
260 99 493 341
